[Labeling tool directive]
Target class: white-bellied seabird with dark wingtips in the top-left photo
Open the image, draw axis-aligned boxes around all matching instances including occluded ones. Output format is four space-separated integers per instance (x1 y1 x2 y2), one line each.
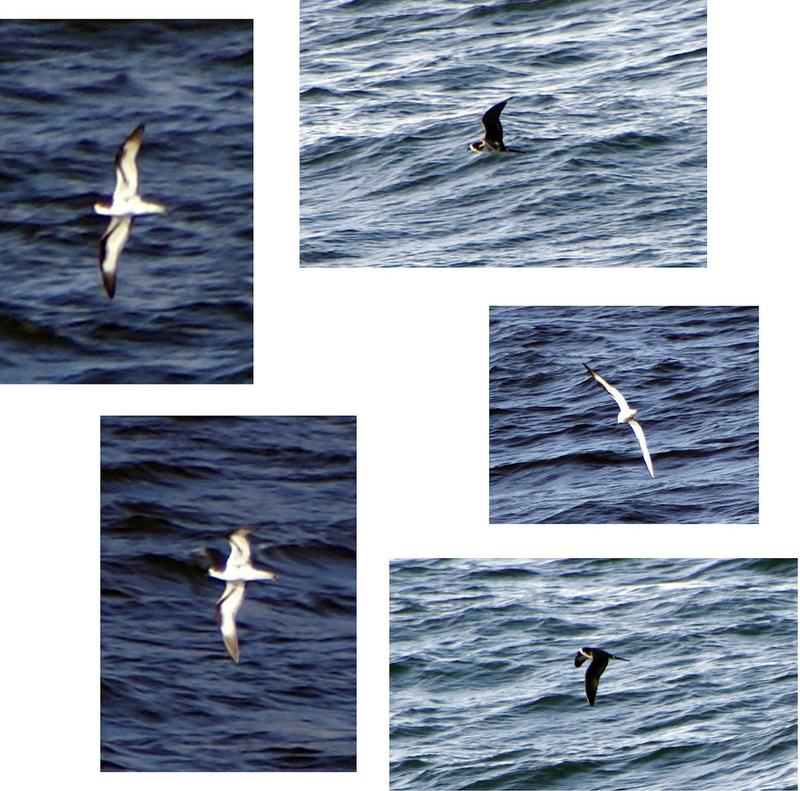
94 124 166 298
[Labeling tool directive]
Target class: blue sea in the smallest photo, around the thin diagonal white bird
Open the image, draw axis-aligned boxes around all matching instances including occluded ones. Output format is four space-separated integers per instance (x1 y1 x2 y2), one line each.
489 306 759 524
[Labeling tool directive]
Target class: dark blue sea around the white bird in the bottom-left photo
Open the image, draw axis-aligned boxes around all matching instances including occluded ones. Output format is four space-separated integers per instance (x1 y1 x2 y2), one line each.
100 417 356 771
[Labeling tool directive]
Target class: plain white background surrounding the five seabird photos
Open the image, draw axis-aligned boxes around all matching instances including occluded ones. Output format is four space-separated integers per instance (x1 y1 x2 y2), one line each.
0 0 800 791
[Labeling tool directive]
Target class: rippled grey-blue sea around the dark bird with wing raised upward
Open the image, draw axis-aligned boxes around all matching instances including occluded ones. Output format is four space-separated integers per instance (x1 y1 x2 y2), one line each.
300 0 706 267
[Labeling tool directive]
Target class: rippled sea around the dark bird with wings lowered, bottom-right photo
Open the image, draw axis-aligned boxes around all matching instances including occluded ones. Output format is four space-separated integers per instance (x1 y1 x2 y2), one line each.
389 559 797 791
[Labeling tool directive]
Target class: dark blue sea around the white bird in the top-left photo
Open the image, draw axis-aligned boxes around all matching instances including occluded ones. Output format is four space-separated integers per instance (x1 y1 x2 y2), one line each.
0 20 253 383
